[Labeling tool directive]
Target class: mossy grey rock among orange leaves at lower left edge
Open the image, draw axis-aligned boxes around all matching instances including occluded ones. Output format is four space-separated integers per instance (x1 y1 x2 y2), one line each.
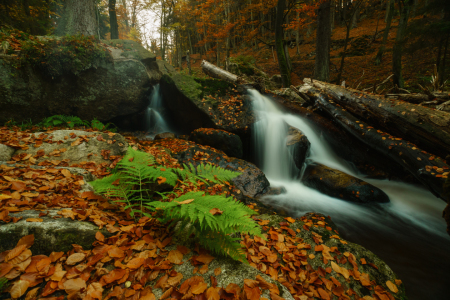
0 210 112 255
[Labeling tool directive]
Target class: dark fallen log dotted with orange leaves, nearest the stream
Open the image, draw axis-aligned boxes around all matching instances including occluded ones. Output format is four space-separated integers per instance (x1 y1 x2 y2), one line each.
309 86 450 202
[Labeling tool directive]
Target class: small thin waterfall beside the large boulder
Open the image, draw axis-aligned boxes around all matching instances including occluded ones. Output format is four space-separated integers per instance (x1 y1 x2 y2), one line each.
145 84 170 134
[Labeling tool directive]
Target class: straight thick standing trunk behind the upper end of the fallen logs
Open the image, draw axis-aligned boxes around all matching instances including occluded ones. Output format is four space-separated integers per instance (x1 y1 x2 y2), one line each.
314 0 331 82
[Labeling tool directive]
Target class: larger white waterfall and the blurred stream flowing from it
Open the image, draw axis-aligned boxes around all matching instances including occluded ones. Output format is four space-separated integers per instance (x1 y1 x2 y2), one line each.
248 90 450 299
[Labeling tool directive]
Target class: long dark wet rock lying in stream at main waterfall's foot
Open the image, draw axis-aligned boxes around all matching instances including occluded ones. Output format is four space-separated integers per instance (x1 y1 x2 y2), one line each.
302 163 389 203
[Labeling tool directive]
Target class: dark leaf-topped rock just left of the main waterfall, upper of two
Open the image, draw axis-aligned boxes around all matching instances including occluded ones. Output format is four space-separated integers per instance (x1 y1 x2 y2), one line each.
189 128 243 158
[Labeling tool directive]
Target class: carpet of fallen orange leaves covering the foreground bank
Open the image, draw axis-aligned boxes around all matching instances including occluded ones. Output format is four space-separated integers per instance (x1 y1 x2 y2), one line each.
0 128 401 300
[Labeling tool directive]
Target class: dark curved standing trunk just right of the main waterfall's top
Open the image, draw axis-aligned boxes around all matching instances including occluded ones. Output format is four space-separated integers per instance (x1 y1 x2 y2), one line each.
275 0 291 87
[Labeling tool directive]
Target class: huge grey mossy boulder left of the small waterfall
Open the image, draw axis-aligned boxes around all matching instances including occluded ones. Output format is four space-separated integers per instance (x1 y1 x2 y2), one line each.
0 40 174 124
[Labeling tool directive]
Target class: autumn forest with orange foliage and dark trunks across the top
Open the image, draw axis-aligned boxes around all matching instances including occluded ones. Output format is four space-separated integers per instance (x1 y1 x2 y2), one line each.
0 0 450 93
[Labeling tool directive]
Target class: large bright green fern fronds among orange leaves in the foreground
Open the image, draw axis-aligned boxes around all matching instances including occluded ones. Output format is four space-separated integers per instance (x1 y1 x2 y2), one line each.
91 147 262 262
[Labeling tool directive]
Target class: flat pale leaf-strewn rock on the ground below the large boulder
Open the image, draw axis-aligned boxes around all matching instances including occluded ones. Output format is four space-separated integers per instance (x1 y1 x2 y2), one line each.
14 130 128 164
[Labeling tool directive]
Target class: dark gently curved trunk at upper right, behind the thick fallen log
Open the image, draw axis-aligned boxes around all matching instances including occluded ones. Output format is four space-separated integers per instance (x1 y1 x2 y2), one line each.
392 0 411 88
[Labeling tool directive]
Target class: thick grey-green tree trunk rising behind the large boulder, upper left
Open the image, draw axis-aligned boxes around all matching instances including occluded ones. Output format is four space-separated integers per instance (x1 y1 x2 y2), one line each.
55 0 98 36
